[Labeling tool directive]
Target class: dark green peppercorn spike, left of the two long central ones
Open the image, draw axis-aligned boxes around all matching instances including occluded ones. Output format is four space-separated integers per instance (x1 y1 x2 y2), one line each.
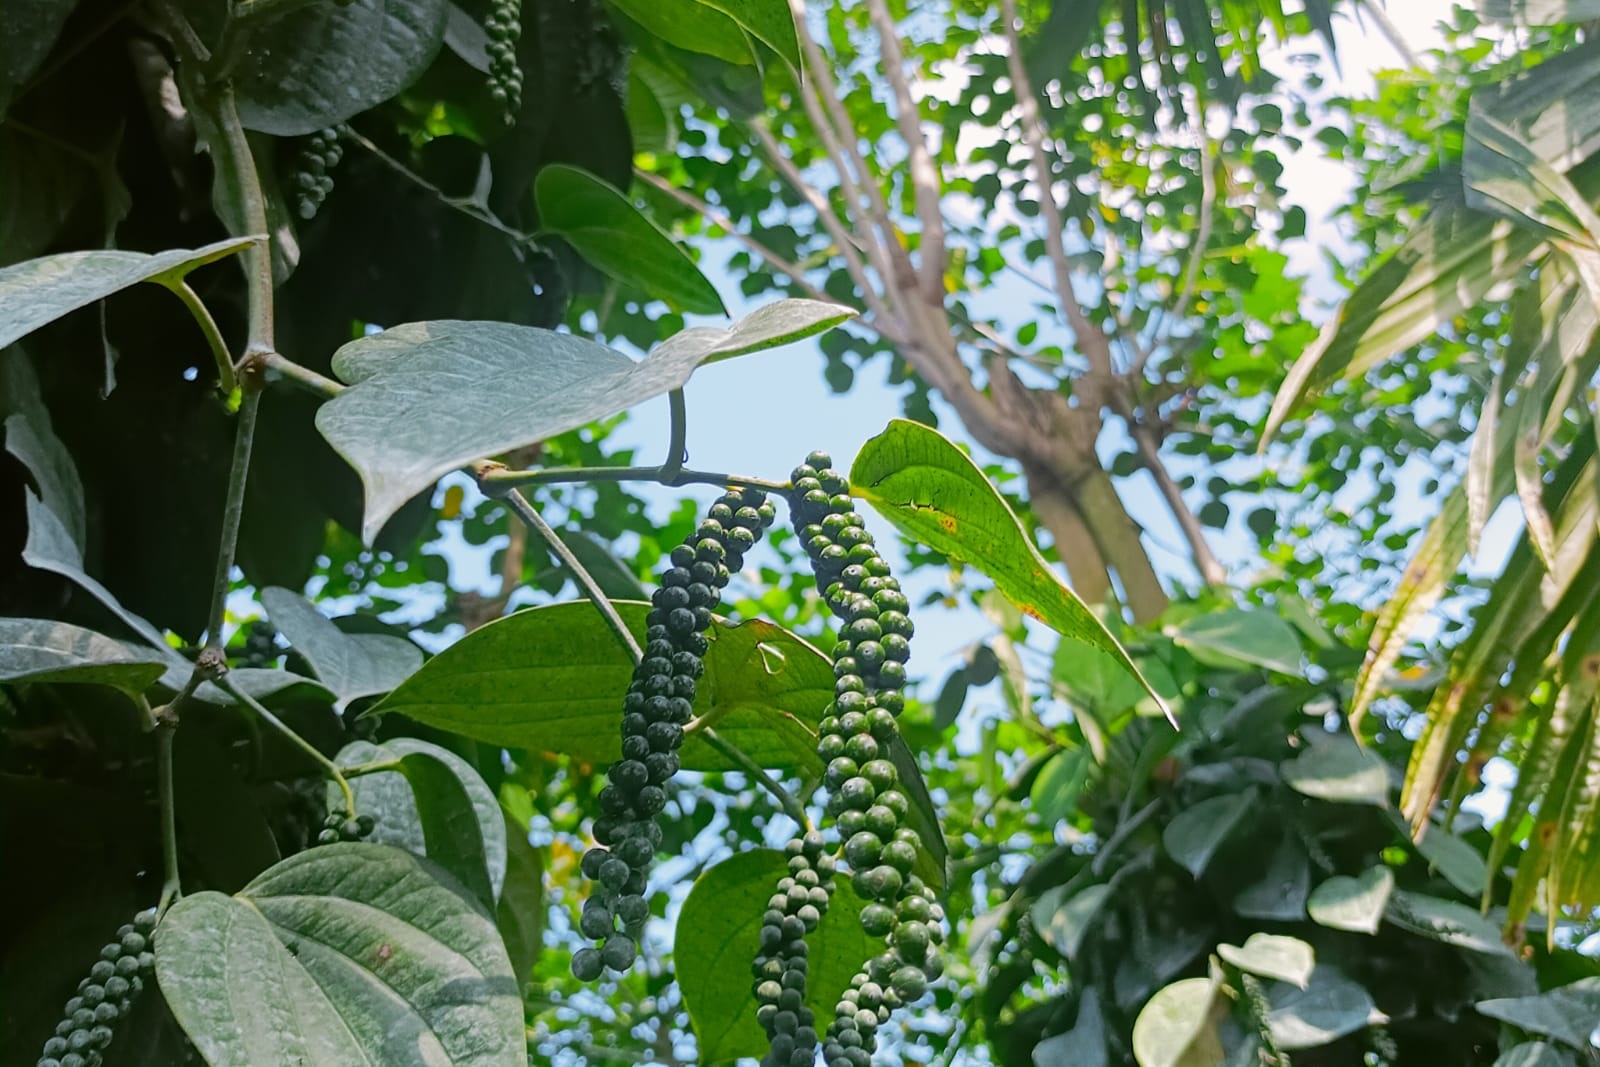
573 490 776 982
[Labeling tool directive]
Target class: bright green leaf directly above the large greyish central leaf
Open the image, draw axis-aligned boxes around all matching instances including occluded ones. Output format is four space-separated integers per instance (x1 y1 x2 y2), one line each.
533 163 728 315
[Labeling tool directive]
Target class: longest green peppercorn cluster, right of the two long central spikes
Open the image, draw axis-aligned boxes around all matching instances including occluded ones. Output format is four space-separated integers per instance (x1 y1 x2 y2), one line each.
792 453 944 1067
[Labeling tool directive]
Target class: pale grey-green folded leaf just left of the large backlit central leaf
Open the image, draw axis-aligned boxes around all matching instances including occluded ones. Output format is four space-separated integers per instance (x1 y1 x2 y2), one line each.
261 587 422 705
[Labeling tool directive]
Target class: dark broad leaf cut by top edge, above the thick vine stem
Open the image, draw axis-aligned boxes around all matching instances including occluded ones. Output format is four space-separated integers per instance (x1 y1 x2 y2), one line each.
234 0 448 138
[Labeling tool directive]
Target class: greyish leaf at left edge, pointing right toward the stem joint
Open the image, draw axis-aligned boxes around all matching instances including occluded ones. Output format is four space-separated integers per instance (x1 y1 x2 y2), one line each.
0 619 168 694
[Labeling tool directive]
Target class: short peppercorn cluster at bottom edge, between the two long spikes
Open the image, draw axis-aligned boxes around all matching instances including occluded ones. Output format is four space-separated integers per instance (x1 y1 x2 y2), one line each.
754 830 834 1067
